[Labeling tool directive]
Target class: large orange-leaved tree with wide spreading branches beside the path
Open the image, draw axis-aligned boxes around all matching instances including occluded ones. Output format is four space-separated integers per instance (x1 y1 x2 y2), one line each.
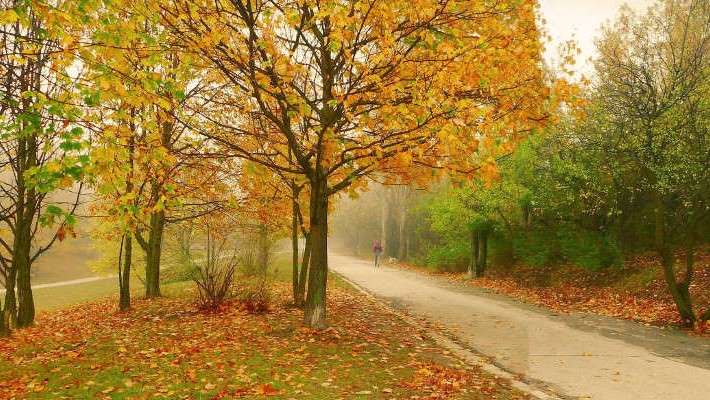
154 0 550 328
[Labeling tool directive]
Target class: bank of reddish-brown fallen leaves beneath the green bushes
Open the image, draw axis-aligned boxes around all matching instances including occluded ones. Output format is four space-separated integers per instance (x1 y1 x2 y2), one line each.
399 249 710 337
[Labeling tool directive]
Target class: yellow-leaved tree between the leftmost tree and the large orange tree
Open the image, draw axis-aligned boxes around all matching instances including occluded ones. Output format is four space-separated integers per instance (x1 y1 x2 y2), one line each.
72 1 229 304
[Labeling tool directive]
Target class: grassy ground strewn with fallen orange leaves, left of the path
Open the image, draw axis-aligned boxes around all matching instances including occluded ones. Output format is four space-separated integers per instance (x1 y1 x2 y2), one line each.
0 284 527 399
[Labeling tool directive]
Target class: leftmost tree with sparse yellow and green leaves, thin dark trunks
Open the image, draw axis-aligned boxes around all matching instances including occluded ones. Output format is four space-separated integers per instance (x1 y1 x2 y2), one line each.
0 0 88 331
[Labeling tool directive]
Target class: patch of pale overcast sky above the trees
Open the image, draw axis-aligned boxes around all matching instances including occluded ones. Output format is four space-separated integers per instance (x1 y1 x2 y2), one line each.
540 0 655 75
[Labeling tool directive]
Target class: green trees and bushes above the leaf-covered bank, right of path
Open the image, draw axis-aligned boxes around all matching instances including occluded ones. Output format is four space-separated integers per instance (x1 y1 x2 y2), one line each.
339 0 710 326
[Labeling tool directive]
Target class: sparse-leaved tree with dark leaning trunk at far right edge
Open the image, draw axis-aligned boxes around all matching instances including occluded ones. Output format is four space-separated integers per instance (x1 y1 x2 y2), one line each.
593 0 710 325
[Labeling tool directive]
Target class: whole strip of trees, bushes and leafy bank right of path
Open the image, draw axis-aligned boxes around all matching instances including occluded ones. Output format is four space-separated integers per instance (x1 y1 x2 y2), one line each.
335 1 710 329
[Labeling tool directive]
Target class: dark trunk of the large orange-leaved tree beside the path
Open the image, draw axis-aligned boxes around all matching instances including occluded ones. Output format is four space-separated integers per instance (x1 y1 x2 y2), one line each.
304 177 328 329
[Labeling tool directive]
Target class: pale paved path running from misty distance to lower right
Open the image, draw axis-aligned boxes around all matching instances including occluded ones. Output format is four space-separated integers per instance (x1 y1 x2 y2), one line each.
329 254 710 400
